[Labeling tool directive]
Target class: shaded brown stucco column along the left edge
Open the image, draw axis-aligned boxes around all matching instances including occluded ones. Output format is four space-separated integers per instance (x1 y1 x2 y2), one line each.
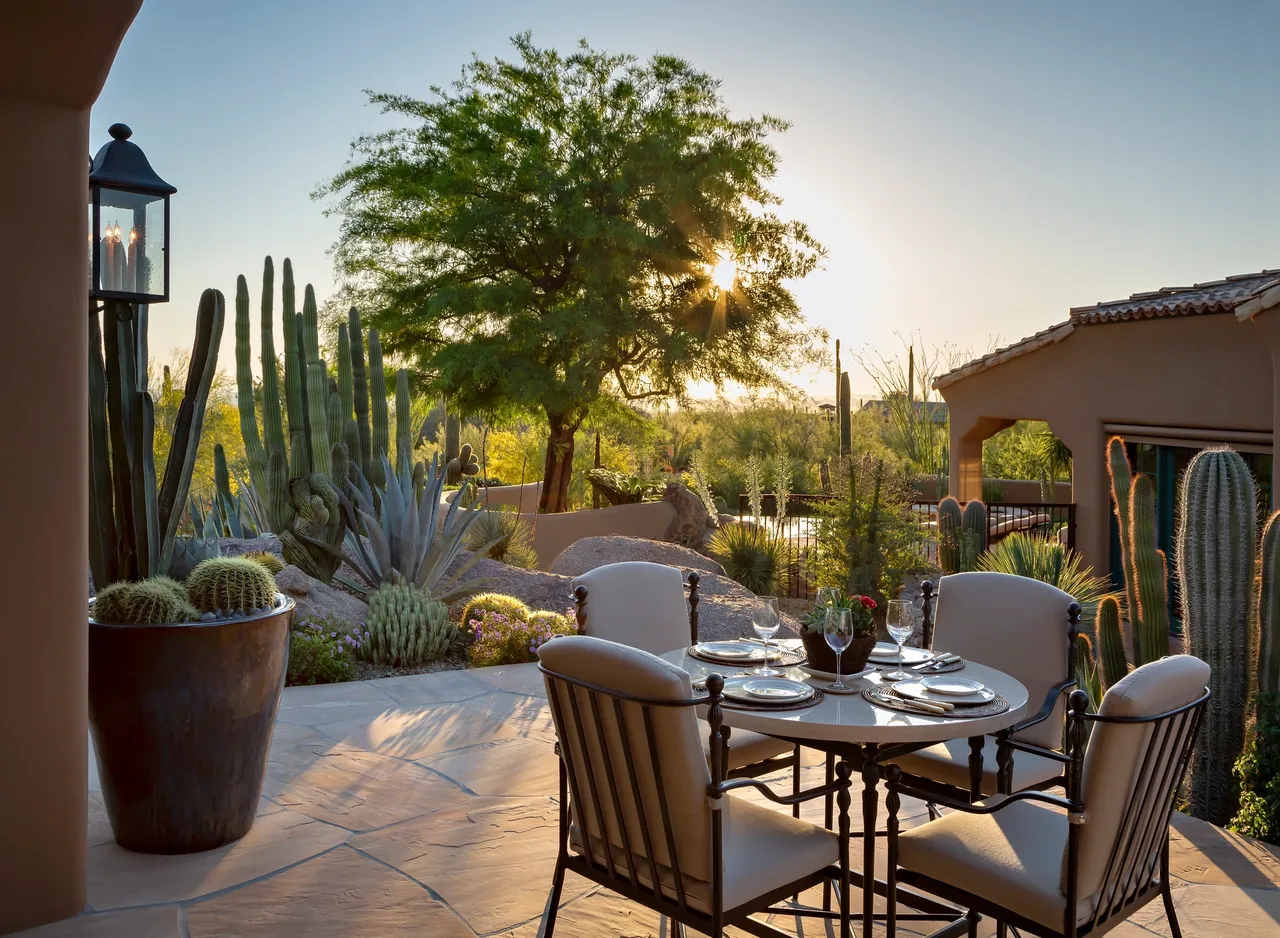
0 0 140 934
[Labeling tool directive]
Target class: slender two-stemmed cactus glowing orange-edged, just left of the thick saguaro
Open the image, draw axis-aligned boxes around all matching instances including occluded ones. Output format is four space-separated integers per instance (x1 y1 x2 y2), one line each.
1107 436 1169 665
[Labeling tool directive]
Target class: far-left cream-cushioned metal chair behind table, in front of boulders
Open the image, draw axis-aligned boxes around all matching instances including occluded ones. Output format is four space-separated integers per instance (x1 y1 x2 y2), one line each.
573 560 800 788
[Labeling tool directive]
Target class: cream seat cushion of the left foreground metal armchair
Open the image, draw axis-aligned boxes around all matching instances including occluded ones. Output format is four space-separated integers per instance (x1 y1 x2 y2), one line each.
570 796 840 914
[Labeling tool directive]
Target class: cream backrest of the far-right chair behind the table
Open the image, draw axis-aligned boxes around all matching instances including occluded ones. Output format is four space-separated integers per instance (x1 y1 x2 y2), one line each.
933 572 1075 758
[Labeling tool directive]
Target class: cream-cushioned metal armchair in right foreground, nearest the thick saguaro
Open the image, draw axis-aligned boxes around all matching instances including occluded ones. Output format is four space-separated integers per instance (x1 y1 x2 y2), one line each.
886 655 1210 938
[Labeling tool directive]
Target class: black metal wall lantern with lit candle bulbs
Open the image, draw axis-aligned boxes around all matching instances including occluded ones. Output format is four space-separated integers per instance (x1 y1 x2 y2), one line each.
88 124 178 303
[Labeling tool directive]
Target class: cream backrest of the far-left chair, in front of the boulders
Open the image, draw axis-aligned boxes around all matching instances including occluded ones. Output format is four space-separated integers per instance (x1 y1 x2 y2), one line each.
573 560 690 655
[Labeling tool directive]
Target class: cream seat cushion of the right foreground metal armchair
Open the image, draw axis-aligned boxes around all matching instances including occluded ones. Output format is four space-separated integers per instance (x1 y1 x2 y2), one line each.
897 798 1092 932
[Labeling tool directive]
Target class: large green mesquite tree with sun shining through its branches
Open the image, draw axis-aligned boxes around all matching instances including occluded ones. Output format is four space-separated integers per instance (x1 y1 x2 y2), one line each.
315 35 823 511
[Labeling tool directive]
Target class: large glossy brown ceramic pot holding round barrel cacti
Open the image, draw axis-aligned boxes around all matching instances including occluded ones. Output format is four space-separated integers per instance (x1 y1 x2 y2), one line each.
88 595 294 854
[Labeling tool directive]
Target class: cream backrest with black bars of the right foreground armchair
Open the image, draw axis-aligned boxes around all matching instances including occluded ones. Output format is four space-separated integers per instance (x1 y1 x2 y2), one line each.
1064 655 1210 925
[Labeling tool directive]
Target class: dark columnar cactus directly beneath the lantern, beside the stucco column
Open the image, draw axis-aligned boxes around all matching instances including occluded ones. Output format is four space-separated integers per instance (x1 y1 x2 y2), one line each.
88 290 225 585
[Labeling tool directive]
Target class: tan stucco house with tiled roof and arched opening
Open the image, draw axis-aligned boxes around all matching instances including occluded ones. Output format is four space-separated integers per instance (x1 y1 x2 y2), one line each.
933 269 1280 572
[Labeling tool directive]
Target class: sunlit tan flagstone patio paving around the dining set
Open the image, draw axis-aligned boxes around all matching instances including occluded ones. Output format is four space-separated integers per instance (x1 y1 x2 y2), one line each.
22 664 1280 938
